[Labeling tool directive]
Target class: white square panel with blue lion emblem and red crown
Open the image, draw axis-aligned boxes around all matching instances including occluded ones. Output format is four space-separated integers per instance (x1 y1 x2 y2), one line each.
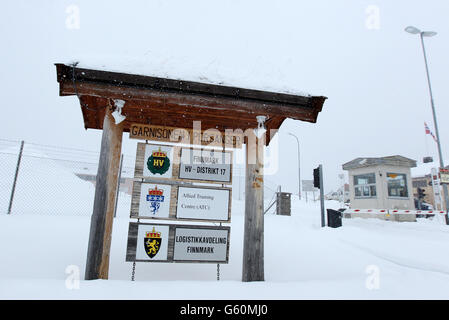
139 183 172 218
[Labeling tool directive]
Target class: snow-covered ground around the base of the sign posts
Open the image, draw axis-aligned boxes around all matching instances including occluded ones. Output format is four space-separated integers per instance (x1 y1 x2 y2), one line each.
0 198 449 299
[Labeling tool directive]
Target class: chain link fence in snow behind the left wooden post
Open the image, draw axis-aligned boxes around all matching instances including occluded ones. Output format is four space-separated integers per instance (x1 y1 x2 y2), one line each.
0 139 134 216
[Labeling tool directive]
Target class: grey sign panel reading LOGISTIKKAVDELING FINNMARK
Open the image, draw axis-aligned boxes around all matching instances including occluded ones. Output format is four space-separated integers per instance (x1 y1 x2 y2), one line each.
173 228 229 262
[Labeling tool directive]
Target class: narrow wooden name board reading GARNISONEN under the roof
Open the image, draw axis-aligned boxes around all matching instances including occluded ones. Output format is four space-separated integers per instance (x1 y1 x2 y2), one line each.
129 123 243 148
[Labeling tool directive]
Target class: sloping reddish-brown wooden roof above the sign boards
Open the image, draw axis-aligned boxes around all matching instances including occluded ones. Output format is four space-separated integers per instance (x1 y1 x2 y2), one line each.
56 64 326 144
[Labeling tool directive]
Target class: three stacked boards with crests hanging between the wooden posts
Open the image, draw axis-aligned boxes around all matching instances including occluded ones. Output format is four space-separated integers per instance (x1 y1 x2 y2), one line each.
126 143 232 263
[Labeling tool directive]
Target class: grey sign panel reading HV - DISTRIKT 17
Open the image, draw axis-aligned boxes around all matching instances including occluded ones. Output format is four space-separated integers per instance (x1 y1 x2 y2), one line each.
179 148 232 182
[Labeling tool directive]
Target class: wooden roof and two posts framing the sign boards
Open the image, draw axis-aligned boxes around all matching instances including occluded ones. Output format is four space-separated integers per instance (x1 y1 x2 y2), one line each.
56 62 327 281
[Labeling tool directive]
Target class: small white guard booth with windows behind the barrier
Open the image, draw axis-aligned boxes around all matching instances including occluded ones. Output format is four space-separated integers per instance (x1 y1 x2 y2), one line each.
342 155 416 210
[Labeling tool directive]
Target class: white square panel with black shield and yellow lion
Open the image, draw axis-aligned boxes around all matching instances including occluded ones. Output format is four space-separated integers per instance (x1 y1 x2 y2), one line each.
136 224 170 261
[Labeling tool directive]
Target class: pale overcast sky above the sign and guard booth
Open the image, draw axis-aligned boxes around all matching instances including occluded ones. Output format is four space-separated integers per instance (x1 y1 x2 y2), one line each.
0 0 449 192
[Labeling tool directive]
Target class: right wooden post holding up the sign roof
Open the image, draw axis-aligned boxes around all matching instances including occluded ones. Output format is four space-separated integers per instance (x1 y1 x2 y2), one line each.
242 130 265 282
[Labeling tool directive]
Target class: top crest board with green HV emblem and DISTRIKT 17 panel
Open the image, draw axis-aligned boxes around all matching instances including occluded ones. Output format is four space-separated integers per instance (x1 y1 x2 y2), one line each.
134 143 232 184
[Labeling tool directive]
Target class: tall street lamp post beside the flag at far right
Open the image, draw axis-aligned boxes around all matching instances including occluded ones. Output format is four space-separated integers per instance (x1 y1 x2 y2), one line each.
405 26 449 224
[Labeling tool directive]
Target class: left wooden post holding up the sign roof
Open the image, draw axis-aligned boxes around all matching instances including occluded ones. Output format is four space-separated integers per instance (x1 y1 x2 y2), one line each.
85 108 123 280
